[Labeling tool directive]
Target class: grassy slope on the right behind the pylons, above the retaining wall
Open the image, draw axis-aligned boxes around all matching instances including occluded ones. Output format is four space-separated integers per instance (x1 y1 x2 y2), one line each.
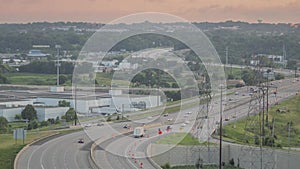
223 95 300 147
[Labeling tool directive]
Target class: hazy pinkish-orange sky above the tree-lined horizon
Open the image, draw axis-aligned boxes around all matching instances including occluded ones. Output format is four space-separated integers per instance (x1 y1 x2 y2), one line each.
0 0 300 23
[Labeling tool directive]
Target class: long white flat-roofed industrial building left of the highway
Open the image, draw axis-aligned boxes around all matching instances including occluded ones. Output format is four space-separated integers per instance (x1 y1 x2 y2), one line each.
0 89 161 121
